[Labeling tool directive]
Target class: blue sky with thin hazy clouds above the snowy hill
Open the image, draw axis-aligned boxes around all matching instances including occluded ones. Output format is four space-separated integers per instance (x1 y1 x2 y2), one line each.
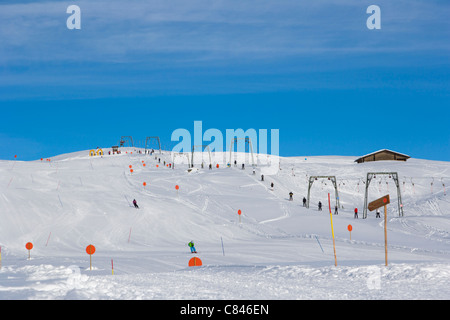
0 0 450 161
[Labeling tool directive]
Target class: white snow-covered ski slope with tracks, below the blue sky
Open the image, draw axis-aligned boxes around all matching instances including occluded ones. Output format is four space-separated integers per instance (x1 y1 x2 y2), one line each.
0 148 450 300
